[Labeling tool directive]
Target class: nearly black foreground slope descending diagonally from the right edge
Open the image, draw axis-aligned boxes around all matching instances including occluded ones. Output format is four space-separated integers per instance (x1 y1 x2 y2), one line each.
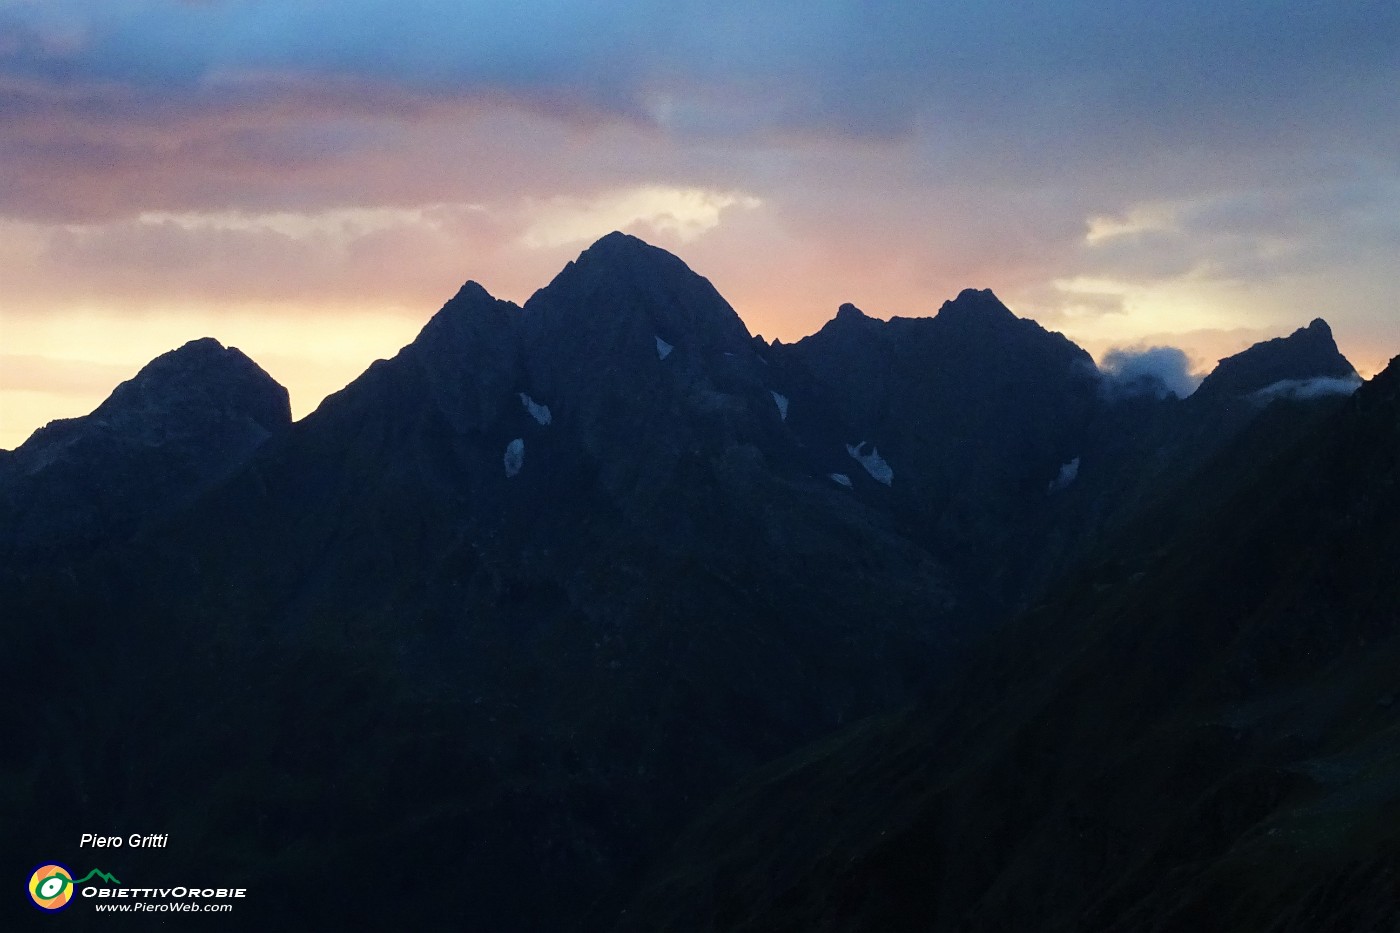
619 355 1400 932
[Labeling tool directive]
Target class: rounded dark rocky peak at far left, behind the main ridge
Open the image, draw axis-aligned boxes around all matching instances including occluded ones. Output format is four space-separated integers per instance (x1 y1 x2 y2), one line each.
0 338 291 563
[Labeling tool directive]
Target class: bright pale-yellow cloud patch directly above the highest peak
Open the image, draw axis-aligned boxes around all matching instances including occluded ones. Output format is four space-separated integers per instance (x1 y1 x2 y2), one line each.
521 185 763 249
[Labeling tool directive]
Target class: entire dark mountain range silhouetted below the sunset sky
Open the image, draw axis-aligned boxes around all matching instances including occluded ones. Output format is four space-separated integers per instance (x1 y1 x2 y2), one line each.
0 234 1383 930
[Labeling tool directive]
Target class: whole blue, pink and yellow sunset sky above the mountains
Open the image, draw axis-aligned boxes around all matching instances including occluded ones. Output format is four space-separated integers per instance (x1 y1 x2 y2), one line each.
0 0 1400 448
